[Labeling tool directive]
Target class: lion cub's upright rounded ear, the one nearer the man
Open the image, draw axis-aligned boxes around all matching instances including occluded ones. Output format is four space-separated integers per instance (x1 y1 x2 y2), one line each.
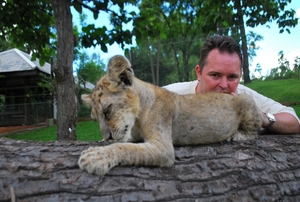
107 55 134 86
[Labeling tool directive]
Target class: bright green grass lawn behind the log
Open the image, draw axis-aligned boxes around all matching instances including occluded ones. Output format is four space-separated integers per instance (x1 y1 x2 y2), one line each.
2 79 300 141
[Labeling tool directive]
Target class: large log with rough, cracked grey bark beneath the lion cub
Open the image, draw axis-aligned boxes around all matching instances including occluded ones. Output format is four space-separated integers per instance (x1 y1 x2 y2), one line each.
0 134 300 202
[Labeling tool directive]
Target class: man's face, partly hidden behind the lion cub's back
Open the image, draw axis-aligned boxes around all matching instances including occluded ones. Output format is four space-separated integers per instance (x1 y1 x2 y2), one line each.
196 49 242 94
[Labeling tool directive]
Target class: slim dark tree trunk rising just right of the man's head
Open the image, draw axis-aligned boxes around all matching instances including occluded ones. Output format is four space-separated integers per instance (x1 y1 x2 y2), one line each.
235 0 251 83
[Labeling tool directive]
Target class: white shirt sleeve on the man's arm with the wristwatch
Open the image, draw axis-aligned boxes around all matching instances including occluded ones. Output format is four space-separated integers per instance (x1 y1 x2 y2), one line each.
236 84 300 123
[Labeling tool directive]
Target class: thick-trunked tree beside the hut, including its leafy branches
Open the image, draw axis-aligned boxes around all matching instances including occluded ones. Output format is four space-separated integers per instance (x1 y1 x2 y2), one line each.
0 0 135 140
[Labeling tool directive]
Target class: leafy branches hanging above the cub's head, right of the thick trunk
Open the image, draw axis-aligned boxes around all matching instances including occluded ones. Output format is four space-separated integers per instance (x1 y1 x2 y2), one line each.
72 0 136 52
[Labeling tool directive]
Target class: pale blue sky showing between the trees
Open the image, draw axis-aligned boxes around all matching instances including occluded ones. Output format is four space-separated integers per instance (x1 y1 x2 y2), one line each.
72 0 300 75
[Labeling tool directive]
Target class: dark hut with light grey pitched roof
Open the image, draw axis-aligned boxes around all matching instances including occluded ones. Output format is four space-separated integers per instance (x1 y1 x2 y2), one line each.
0 49 55 126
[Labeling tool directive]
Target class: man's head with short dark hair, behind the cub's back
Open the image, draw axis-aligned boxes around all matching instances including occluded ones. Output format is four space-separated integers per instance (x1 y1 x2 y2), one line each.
195 36 242 93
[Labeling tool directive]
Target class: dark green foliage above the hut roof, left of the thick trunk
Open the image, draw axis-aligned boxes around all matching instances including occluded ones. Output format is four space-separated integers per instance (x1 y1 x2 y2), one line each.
0 0 55 64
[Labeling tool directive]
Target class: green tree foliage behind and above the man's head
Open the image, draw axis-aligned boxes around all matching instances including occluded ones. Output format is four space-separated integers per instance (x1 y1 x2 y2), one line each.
133 0 298 83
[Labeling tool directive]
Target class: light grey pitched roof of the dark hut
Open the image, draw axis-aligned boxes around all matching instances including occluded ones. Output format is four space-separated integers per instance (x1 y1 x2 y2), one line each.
0 48 51 74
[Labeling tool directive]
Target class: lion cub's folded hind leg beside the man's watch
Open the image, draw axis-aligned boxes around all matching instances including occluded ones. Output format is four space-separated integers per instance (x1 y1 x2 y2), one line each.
232 94 262 141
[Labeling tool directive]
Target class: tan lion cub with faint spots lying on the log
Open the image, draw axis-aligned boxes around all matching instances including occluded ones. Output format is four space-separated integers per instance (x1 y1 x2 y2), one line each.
78 55 261 175
